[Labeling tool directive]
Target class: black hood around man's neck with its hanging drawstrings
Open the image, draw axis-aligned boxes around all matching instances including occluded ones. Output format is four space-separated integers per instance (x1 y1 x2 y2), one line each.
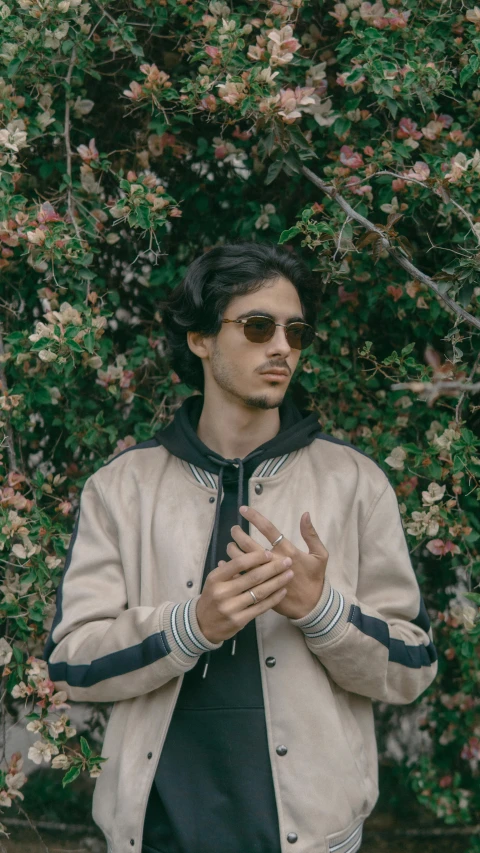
154 393 320 677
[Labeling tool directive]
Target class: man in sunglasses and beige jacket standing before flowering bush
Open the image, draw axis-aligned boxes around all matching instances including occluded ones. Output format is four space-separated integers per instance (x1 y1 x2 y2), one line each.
44 243 437 853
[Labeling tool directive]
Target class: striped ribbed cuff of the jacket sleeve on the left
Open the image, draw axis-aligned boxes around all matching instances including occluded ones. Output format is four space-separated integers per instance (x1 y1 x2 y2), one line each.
162 595 223 663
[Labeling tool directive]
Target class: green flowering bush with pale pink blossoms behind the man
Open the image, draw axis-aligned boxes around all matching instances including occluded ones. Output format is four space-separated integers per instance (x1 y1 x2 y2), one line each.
0 0 480 851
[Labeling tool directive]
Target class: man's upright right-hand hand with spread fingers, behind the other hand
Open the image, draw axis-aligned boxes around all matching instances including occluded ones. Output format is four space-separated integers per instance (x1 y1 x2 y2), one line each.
227 507 328 619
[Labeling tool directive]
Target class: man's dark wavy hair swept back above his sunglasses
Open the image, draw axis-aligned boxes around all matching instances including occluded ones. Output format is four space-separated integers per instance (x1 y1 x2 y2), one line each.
159 240 319 393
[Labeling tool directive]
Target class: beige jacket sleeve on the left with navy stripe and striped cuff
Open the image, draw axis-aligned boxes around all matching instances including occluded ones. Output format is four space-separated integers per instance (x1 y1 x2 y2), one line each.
43 475 222 702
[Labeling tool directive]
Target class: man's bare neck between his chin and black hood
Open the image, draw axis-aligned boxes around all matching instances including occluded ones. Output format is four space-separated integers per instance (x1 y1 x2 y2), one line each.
197 398 280 459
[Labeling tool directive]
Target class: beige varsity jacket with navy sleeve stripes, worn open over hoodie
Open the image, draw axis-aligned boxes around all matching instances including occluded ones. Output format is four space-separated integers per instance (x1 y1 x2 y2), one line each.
44 392 437 853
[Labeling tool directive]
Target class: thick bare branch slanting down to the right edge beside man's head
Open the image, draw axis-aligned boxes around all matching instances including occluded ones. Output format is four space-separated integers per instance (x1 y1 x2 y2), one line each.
301 166 480 329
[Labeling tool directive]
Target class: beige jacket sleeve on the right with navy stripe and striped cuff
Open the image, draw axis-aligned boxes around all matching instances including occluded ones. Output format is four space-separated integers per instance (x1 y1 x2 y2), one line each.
290 481 438 705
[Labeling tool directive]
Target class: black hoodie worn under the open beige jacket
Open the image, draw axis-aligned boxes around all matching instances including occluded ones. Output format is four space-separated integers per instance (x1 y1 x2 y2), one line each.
142 393 320 853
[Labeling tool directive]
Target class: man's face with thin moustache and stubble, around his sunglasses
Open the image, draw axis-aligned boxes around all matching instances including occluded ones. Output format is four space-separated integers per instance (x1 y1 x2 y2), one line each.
191 277 304 409
